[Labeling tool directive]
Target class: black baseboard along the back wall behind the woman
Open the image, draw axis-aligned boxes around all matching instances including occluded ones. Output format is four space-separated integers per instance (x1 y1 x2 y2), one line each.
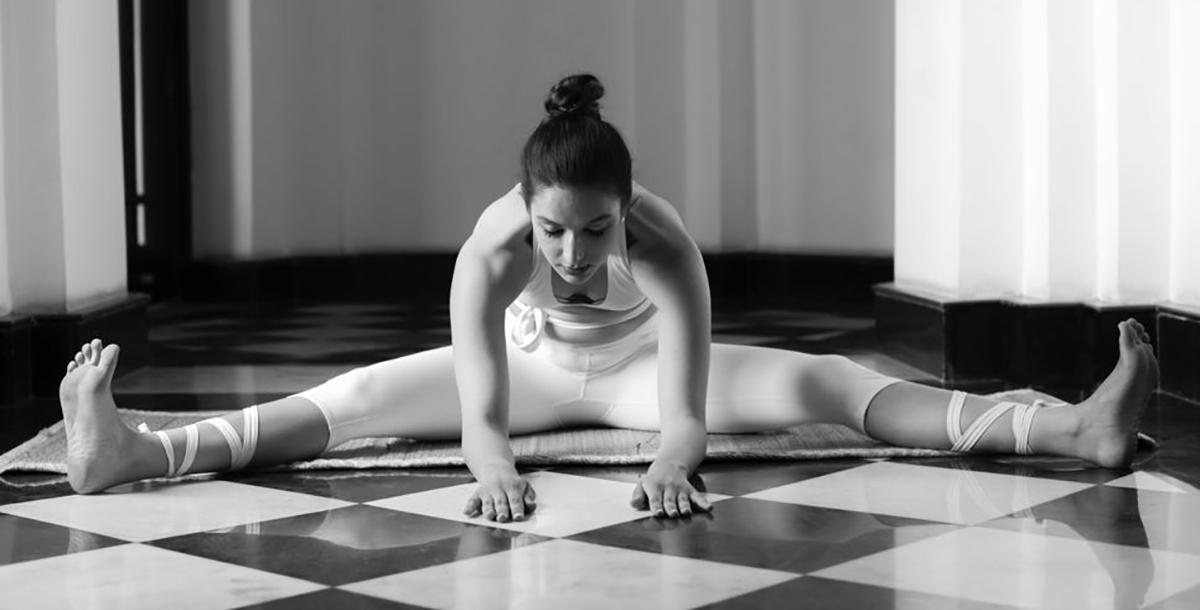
181 252 893 309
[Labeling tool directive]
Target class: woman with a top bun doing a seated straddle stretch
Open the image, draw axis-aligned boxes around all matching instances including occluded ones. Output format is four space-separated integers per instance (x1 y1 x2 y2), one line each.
60 74 1157 521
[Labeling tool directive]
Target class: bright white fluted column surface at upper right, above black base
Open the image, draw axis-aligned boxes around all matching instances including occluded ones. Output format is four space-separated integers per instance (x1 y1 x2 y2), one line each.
895 0 1200 305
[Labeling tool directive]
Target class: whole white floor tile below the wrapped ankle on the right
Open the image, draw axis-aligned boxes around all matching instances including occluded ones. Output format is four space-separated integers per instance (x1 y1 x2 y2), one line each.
745 462 1090 525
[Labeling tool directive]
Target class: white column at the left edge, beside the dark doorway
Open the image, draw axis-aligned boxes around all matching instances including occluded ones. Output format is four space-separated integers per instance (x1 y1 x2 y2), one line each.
0 0 126 313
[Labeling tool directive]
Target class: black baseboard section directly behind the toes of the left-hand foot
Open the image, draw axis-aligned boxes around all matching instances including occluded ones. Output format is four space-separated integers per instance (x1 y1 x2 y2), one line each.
29 294 150 397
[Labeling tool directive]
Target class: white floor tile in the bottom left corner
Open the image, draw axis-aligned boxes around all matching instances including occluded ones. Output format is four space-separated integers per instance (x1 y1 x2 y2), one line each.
0 544 324 610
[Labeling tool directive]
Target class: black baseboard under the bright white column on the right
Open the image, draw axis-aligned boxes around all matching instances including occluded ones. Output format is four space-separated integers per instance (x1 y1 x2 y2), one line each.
875 283 1180 401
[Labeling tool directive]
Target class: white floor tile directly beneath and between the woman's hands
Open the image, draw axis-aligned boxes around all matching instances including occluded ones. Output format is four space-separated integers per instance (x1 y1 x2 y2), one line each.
368 472 728 537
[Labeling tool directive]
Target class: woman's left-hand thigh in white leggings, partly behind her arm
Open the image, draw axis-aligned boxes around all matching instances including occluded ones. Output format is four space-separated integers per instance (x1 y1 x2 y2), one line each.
299 346 577 445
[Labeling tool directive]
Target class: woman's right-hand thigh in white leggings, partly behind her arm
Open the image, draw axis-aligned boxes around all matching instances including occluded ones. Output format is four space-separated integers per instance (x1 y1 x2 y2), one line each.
589 343 898 433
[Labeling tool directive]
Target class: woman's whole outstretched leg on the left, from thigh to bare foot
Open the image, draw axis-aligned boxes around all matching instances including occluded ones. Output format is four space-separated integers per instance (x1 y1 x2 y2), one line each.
59 340 578 494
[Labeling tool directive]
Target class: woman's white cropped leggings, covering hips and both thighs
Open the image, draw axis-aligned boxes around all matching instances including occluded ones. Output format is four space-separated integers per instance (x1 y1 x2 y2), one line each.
295 311 900 448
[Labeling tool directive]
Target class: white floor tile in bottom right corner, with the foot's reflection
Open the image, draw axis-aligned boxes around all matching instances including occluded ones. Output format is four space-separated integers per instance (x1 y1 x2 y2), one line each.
814 527 1200 609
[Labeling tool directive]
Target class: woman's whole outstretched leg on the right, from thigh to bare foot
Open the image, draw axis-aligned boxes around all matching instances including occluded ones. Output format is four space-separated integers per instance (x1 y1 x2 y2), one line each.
588 321 1158 466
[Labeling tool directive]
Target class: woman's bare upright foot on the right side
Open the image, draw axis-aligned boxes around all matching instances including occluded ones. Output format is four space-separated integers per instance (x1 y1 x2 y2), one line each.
1074 318 1158 468
